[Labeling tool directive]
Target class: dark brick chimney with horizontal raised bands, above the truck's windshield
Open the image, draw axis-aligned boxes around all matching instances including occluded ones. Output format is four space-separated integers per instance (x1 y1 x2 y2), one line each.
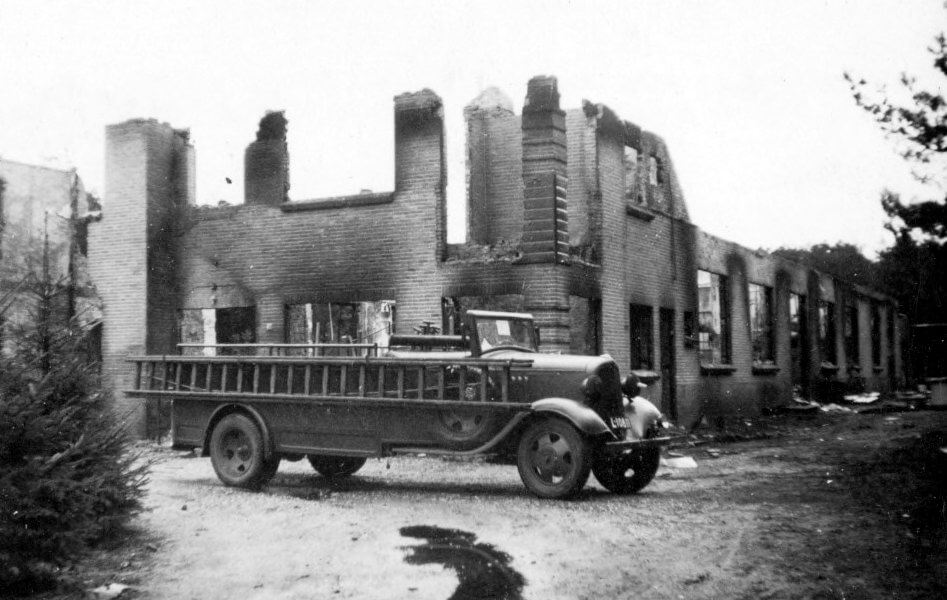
521 76 569 264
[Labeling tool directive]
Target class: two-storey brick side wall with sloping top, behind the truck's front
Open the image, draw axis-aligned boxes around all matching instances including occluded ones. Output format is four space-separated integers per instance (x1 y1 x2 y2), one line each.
588 107 699 422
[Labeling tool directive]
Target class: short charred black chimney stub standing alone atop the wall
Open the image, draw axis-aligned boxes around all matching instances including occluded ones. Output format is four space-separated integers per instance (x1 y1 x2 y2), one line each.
243 111 289 206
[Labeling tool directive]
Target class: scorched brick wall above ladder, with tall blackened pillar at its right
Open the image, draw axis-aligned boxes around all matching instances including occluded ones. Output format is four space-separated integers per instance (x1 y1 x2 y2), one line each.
181 95 452 342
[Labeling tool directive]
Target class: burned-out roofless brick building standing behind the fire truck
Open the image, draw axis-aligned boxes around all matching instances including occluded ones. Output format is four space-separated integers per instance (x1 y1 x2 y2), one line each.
90 77 903 433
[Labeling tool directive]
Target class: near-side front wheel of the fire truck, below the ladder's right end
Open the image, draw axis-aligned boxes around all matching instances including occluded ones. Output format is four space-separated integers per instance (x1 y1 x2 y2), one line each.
516 418 592 499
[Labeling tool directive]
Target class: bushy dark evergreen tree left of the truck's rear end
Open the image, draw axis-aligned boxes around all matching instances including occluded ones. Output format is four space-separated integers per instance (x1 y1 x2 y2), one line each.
0 234 147 596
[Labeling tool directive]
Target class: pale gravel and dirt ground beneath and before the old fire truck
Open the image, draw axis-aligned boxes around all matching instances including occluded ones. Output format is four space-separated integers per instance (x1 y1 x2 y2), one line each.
72 412 947 600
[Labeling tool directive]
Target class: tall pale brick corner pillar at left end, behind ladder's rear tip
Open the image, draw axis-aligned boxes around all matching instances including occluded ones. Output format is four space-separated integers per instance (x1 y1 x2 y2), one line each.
88 120 194 436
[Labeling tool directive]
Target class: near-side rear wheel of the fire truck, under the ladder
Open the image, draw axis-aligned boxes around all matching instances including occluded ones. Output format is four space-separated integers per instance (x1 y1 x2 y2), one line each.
210 413 266 490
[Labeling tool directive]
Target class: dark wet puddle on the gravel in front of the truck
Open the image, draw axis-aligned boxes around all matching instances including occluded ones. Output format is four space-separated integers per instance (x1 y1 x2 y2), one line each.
399 525 526 600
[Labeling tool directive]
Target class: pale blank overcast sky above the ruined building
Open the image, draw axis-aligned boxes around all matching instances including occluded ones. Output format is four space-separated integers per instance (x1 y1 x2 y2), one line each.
0 0 947 256
